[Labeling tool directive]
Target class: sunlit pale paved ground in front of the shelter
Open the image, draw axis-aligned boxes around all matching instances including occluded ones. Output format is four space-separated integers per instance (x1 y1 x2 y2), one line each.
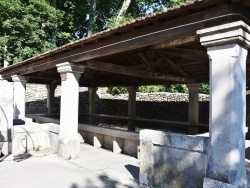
0 145 145 188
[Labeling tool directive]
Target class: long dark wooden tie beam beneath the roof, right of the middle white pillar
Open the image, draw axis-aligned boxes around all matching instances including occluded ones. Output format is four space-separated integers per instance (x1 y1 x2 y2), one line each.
82 60 195 82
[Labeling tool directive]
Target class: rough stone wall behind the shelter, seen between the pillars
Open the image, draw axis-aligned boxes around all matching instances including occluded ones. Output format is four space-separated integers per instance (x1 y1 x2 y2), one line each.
26 84 209 123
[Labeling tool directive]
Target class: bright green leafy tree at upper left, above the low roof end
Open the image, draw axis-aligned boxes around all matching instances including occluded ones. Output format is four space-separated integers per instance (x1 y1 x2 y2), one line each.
0 0 62 65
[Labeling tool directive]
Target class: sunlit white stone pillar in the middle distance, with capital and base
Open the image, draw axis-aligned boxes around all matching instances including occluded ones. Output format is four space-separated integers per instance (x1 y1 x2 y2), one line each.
56 63 82 159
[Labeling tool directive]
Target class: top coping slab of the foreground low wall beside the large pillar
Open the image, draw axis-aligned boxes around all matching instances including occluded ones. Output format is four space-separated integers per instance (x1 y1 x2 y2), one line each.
140 129 209 153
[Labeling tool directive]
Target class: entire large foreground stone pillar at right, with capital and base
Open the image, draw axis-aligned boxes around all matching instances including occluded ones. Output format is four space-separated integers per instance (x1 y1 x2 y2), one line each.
198 21 250 188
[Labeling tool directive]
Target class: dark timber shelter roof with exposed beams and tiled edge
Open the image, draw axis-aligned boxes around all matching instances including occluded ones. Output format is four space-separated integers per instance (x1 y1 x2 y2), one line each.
0 0 250 86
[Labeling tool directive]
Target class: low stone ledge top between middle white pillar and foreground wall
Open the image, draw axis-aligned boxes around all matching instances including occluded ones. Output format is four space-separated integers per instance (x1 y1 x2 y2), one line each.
78 124 139 140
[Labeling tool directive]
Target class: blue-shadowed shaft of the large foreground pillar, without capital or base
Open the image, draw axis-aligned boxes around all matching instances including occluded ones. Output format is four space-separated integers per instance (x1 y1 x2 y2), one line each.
204 44 247 187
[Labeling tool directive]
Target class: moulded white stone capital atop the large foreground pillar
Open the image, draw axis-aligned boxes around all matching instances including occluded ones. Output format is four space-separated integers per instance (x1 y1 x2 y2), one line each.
197 21 250 49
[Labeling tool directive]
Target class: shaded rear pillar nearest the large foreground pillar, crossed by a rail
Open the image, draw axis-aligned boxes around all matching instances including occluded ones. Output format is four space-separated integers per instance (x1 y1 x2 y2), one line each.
186 83 201 135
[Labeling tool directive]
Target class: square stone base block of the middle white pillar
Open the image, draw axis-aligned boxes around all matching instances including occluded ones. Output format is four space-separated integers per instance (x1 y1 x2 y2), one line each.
58 137 80 160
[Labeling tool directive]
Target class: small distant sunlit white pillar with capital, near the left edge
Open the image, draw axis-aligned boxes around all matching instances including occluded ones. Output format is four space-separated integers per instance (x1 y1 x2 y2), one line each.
11 75 28 120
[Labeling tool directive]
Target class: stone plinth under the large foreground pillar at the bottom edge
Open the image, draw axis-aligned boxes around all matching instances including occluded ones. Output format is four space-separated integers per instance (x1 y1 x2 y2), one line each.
203 178 247 188
